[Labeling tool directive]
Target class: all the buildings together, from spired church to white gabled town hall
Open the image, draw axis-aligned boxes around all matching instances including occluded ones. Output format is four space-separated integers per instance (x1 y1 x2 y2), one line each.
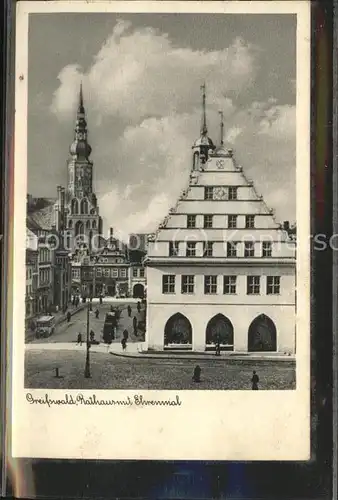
27 86 296 354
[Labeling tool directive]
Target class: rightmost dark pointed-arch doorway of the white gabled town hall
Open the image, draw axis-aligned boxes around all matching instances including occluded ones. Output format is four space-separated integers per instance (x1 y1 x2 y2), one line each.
248 314 277 352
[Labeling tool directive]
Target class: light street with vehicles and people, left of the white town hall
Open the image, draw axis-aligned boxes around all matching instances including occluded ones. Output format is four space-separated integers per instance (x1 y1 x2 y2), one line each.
30 301 143 344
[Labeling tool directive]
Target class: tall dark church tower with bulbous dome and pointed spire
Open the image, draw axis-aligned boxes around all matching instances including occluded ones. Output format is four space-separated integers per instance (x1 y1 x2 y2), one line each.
66 84 102 248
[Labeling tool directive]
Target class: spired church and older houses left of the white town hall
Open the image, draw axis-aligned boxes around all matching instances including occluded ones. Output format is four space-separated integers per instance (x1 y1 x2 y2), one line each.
26 87 147 324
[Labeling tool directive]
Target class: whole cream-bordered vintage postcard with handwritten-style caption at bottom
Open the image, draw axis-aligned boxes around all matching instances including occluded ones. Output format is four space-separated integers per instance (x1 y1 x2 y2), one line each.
11 0 310 460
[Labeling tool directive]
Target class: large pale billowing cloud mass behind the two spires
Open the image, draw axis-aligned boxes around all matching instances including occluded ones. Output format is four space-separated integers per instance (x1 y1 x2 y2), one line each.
51 20 295 234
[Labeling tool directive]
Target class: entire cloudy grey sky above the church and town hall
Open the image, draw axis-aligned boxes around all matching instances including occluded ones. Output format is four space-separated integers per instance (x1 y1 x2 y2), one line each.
28 13 296 233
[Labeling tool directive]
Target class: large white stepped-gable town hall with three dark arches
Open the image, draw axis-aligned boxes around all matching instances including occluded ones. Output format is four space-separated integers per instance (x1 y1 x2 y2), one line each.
145 86 296 354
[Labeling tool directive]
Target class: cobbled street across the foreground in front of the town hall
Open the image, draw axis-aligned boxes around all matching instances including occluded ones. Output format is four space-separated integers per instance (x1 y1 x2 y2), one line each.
25 347 296 390
